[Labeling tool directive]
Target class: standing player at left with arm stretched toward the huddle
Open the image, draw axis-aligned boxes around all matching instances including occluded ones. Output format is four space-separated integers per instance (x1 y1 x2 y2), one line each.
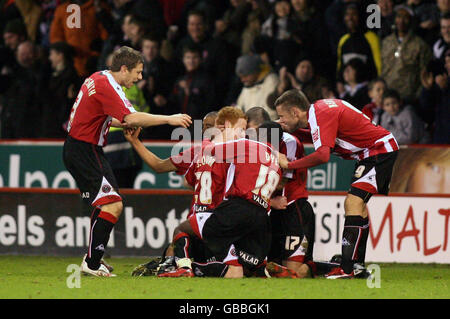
63 47 191 277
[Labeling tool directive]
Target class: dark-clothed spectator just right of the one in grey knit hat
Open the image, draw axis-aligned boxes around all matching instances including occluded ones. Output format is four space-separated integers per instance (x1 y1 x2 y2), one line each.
269 59 327 105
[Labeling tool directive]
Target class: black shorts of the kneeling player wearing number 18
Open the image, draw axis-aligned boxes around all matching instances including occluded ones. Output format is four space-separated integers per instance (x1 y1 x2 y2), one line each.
189 197 271 269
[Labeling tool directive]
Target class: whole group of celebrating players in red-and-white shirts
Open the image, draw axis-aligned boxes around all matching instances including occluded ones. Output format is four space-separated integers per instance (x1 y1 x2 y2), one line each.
64 48 398 279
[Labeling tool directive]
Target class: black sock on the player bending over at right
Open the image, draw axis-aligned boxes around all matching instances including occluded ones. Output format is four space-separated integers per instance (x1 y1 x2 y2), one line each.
341 216 364 274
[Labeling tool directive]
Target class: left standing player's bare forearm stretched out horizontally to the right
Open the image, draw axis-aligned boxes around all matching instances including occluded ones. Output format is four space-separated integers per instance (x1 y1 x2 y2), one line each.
123 112 192 128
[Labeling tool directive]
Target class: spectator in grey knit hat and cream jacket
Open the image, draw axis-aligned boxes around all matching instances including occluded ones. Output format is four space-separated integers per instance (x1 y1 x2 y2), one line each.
236 55 280 120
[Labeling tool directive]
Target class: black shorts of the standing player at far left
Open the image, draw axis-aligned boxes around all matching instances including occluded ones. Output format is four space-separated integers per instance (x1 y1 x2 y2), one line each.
63 136 122 206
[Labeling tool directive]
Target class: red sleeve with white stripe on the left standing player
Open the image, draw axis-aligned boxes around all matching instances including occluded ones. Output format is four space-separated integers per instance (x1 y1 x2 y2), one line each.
94 72 136 122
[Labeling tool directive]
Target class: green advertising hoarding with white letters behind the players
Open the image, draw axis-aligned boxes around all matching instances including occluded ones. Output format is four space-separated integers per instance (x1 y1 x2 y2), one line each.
0 141 354 191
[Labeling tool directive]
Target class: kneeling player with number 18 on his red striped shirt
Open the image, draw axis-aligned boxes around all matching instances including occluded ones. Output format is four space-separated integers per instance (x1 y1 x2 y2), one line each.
159 121 297 278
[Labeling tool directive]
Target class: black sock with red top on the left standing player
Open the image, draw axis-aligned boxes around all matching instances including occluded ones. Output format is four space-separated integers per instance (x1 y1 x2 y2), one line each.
86 211 117 270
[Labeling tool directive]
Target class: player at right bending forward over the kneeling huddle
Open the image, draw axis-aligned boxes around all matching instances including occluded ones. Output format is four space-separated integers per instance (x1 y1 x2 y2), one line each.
275 90 399 279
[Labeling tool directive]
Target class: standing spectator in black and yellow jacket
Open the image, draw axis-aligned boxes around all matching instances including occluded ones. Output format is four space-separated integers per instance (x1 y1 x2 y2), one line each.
337 3 381 80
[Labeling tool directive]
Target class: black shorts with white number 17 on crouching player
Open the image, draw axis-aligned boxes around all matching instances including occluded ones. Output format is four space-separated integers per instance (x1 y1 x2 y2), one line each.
268 198 314 264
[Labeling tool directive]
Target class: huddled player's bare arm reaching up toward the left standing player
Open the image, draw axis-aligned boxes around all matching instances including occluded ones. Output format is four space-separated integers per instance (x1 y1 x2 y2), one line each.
123 127 177 173
